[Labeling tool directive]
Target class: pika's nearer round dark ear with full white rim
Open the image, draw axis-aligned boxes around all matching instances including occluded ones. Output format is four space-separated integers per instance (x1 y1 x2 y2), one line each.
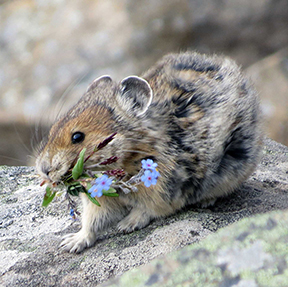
117 76 153 116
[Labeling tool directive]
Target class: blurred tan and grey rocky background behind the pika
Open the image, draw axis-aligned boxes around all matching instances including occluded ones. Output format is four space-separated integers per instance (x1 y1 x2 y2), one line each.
0 0 288 165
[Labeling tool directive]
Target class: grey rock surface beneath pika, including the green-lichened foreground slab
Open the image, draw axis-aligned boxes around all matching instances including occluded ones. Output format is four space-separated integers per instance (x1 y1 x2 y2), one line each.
0 139 288 287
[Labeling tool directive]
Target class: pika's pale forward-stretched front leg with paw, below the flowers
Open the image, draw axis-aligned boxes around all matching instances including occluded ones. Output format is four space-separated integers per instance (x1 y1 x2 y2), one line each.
60 193 127 253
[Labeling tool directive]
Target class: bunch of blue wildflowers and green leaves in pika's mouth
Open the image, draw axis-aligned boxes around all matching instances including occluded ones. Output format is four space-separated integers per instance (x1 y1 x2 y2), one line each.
41 133 160 220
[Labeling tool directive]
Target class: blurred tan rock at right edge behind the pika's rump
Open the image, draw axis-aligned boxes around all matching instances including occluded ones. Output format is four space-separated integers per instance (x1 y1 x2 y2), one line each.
247 48 288 145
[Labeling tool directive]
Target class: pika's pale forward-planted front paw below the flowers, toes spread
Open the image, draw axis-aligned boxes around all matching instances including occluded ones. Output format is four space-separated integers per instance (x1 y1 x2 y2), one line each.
59 230 96 253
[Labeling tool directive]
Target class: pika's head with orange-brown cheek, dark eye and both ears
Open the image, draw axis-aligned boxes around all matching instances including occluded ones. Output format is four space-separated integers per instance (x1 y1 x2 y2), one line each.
36 76 153 184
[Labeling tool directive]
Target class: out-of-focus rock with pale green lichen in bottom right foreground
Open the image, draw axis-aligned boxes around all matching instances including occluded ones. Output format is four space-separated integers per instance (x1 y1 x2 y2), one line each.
101 210 288 287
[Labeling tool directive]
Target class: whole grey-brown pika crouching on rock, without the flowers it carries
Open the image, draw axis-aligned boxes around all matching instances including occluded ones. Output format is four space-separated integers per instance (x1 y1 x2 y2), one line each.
36 52 262 252
